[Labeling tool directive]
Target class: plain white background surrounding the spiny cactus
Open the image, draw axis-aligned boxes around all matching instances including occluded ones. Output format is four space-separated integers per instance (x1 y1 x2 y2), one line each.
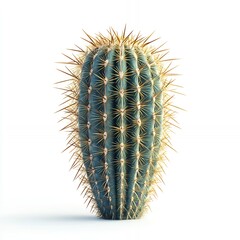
0 0 240 240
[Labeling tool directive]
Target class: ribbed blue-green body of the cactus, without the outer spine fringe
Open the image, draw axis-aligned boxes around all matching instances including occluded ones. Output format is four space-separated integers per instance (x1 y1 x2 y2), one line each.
78 45 161 219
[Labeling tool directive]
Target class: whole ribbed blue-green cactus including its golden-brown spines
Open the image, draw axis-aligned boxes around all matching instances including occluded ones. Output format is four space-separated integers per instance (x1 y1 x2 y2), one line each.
58 28 180 219
